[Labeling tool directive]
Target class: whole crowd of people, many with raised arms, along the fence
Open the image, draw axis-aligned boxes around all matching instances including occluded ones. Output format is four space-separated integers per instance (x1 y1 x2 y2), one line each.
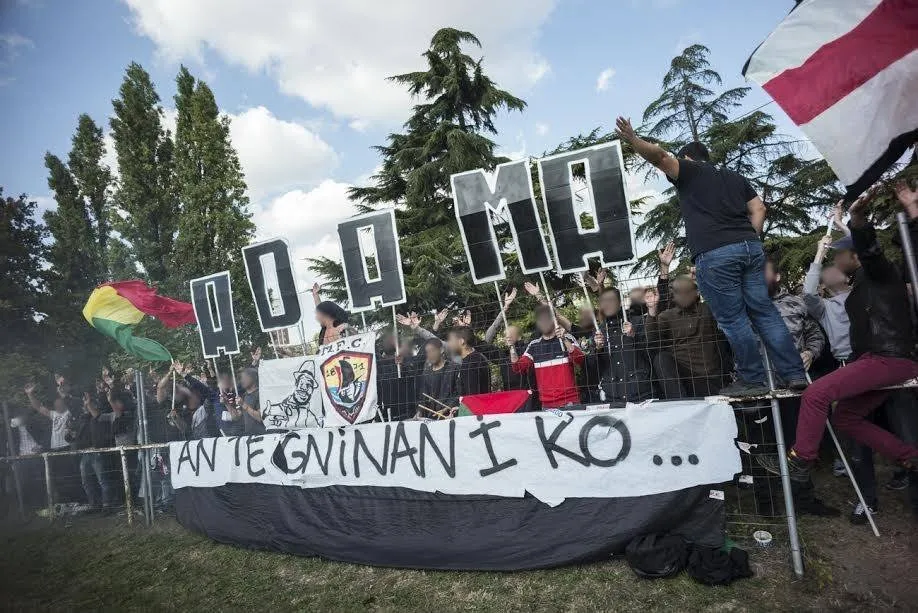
11 126 918 523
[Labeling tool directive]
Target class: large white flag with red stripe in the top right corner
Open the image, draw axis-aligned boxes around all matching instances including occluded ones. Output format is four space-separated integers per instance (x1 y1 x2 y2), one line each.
743 0 918 199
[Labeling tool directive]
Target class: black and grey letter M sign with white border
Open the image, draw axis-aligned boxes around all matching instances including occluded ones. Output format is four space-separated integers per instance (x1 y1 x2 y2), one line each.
450 160 551 284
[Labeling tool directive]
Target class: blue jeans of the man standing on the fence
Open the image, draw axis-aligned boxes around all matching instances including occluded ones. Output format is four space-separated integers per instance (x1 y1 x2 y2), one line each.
695 241 805 384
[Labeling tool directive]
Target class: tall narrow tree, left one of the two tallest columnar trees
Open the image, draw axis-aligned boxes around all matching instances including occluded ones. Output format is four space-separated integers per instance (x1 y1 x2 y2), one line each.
111 63 179 291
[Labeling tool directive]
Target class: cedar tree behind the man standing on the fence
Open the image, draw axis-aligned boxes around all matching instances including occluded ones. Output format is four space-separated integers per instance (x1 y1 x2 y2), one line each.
626 45 841 278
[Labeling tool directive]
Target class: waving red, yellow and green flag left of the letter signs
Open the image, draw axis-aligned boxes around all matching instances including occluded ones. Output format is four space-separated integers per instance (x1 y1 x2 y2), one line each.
83 281 196 362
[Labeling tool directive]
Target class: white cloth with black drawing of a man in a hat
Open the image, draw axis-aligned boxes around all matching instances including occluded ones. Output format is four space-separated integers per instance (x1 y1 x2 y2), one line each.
258 356 325 430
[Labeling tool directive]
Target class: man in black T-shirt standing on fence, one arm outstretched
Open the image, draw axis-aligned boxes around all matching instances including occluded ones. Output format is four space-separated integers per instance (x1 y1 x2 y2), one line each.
616 117 807 396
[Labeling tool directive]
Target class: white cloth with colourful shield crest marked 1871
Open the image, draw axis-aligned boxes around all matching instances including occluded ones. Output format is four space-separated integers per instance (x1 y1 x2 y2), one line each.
318 332 377 427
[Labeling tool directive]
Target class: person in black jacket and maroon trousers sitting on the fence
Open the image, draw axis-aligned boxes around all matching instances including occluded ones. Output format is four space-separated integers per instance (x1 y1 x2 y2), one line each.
757 197 918 481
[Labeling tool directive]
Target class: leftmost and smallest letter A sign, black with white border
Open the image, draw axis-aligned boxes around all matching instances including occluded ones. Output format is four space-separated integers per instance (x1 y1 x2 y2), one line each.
189 270 239 358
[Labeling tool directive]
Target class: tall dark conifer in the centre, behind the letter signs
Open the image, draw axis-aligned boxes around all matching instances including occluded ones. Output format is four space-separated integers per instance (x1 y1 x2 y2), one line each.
310 28 526 320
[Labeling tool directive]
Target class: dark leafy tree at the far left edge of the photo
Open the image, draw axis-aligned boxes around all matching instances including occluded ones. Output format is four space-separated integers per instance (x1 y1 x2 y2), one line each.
0 187 50 410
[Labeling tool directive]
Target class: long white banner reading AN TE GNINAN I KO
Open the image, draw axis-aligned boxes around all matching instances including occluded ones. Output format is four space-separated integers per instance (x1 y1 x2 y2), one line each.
169 400 740 505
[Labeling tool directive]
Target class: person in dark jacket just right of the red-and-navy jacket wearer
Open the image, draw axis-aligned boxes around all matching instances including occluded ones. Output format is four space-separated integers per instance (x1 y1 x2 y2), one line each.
586 287 653 406
